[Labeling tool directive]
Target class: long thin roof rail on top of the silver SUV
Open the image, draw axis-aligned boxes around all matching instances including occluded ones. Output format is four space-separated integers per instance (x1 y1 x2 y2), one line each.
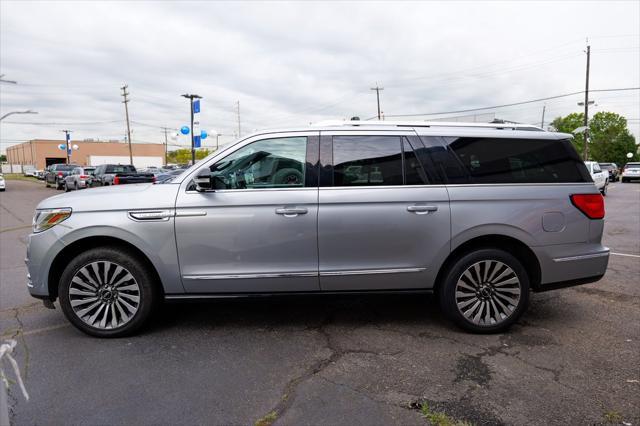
311 120 544 132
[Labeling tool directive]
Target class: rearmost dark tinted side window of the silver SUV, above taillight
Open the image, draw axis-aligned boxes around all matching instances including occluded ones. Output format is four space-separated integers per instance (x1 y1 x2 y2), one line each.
445 138 591 183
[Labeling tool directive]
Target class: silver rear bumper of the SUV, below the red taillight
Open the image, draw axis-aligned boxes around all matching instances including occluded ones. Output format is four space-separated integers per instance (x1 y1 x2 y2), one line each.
534 244 609 291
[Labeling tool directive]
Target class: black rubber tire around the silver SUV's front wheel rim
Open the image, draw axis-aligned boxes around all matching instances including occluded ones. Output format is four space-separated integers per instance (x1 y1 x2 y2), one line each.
58 247 161 337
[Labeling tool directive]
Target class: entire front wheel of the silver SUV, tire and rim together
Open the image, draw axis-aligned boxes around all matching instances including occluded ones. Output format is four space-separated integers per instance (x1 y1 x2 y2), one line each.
58 247 159 337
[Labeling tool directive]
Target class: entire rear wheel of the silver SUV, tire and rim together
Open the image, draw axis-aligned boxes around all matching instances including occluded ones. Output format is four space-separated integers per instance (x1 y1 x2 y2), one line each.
438 248 529 333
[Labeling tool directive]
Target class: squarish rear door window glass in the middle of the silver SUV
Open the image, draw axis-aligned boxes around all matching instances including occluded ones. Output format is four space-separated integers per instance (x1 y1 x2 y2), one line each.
333 136 402 186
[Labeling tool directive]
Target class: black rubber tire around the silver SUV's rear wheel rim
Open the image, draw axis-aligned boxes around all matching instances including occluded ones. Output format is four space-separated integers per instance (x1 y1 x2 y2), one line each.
438 248 529 334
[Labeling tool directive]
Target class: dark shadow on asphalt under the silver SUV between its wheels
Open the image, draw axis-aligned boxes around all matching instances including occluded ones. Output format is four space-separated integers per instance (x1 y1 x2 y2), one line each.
147 294 453 332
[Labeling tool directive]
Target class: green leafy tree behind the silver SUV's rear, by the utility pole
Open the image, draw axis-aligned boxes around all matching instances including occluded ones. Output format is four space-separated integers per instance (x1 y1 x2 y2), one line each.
551 111 638 166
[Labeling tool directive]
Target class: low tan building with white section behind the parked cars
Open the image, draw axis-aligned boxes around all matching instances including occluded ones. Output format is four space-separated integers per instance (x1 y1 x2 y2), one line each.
7 139 165 170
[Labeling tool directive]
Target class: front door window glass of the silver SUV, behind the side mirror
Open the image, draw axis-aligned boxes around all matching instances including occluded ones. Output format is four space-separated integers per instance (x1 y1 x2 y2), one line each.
210 136 307 189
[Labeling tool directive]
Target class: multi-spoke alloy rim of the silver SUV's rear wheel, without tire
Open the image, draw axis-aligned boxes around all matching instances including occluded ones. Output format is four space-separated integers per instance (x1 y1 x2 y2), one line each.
456 260 521 326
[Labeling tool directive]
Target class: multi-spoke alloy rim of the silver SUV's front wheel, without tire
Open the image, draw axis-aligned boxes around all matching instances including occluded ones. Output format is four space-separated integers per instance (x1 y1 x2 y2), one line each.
69 261 140 330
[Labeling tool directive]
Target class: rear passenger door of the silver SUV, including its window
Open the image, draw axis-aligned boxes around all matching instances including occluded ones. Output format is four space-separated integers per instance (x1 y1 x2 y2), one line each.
318 131 451 291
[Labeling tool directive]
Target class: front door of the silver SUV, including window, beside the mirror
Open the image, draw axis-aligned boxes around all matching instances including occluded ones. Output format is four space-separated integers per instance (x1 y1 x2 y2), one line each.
175 132 319 293
